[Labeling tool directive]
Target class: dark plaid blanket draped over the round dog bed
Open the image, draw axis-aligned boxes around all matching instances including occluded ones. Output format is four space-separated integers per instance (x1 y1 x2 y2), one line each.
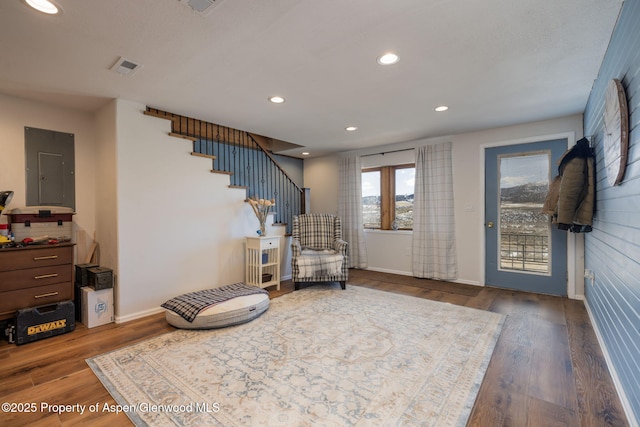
161 282 269 322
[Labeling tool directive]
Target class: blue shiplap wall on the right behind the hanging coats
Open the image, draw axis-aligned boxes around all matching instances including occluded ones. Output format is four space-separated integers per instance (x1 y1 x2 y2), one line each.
584 0 640 425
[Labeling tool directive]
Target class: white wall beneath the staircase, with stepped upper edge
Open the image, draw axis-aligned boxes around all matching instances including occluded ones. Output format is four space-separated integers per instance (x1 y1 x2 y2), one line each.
115 100 284 321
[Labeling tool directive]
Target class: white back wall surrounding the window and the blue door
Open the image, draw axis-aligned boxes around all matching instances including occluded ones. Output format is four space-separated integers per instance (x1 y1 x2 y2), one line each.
304 115 582 296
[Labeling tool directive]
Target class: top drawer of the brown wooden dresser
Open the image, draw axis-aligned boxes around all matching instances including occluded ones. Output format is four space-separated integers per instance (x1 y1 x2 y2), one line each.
0 246 73 271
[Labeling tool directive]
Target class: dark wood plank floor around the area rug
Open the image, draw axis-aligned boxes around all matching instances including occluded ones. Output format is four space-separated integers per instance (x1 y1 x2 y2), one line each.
0 270 628 427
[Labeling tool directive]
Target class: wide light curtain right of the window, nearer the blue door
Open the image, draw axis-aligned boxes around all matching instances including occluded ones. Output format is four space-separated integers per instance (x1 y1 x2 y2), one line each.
412 142 458 280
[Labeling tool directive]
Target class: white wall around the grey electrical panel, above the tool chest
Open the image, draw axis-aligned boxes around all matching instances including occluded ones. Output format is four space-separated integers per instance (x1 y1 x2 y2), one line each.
0 94 98 259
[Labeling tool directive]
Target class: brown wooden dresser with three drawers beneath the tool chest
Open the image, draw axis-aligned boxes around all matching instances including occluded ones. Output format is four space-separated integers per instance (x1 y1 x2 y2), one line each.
0 243 73 320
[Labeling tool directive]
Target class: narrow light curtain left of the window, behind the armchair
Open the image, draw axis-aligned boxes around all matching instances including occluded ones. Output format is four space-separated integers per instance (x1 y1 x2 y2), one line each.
338 155 367 268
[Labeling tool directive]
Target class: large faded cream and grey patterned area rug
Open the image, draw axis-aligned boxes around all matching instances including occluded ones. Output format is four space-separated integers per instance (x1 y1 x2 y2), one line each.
87 285 504 427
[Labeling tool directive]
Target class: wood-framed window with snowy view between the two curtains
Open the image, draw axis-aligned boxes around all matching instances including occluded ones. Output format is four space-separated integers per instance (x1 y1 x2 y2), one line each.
362 165 416 230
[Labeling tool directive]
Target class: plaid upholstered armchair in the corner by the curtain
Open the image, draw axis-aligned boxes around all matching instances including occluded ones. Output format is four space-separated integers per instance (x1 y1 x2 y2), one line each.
291 214 349 290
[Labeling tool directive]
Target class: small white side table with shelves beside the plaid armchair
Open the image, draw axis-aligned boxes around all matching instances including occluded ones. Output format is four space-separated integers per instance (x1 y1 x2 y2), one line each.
245 236 280 290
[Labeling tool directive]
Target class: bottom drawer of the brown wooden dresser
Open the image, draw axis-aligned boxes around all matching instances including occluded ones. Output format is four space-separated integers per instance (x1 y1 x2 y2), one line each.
0 283 73 317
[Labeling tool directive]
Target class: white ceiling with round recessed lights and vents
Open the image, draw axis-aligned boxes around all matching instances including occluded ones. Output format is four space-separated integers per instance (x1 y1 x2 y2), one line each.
0 0 622 156
